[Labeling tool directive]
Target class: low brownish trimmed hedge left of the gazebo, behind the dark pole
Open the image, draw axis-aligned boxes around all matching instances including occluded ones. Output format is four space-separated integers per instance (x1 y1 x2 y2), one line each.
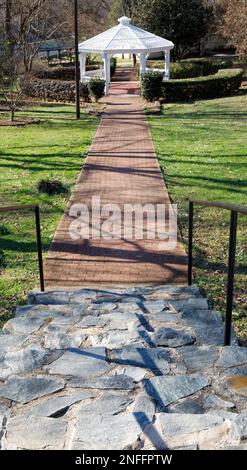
22 78 89 103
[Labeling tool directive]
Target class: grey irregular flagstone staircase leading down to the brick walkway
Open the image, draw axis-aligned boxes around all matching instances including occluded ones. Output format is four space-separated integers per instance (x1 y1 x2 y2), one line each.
0 286 247 450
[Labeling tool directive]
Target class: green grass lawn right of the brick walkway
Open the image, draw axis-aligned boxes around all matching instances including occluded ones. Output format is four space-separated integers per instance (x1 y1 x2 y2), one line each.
148 94 247 339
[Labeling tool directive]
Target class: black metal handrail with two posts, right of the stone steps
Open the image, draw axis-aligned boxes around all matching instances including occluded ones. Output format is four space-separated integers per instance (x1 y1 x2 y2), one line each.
188 198 247 346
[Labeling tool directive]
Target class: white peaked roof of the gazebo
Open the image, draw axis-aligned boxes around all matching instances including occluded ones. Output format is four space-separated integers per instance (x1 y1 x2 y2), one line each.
79 16 174 54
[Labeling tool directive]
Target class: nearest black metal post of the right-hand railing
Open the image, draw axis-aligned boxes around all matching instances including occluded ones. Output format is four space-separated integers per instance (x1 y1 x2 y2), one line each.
224 211 238 346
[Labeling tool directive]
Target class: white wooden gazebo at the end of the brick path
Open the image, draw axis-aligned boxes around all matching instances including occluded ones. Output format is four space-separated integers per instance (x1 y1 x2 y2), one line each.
79 16 174 95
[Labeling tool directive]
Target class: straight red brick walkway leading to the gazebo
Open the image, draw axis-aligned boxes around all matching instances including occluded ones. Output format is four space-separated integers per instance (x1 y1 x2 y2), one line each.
45 83 187 287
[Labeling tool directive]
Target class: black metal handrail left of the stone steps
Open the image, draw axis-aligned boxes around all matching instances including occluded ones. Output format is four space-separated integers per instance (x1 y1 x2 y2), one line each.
0 204 45 292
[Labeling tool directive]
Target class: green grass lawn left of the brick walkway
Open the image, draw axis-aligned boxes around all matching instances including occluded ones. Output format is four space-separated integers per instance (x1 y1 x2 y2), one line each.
0 104 98 324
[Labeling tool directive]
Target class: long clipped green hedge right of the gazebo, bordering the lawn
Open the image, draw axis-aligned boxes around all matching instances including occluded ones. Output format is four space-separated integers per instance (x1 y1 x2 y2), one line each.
162 69 243 102
